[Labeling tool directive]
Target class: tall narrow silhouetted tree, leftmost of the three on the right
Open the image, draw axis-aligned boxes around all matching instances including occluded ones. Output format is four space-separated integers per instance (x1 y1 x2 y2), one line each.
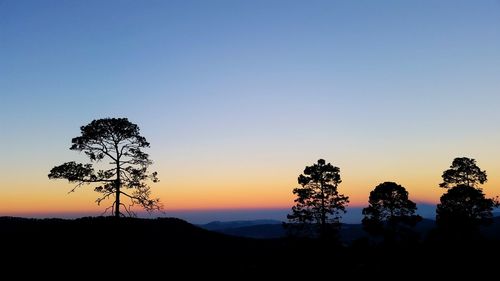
287 159 349 238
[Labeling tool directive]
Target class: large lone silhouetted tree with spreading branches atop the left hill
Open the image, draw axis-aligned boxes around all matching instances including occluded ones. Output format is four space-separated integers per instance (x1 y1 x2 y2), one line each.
48 118 161 217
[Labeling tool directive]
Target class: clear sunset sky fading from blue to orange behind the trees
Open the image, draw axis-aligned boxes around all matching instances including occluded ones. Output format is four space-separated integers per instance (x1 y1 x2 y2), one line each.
0 0 500 222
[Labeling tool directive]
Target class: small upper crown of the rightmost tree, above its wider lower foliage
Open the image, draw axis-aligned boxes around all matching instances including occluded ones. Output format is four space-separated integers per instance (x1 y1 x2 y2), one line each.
439 157 487 188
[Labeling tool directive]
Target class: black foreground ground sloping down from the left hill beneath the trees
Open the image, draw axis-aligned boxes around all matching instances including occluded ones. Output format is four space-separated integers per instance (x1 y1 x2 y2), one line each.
0 217 500 280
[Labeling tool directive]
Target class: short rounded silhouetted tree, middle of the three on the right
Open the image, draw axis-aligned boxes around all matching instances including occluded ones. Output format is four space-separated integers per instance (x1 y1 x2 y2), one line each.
362 182 422 242
